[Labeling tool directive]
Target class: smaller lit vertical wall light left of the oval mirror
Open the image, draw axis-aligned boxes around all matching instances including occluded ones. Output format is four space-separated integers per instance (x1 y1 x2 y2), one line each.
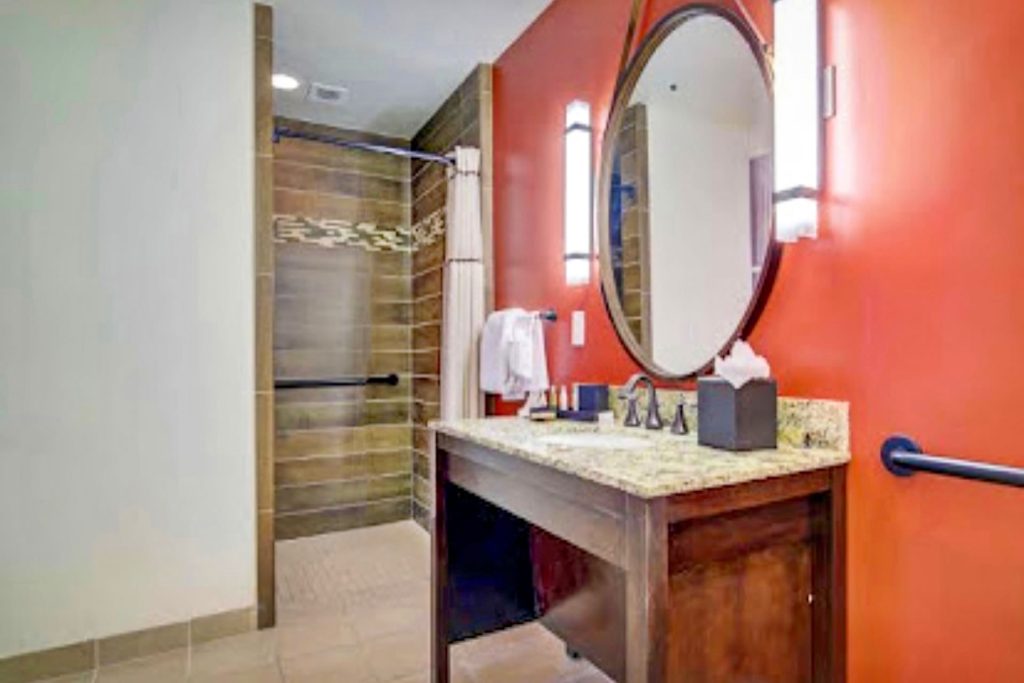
564 99 593 285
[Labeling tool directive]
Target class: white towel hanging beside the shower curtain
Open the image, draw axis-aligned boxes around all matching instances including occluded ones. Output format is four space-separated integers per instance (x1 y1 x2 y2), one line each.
480 308 549 400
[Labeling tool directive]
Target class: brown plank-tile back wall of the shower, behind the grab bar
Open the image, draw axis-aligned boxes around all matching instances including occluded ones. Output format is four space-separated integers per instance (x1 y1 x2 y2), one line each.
273 120 414 539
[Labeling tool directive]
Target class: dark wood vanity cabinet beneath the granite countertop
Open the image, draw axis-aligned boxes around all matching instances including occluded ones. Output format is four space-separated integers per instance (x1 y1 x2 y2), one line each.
433 435 846 683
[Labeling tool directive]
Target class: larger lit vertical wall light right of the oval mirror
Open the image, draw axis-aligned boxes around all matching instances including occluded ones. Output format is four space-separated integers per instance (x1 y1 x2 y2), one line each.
774 0 821 242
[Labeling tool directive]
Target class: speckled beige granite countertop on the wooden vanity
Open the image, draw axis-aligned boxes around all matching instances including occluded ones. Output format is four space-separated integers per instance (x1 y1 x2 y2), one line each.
430 417 850 498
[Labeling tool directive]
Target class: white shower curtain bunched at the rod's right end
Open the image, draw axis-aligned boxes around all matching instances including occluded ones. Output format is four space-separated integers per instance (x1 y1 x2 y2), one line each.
440 147 484 420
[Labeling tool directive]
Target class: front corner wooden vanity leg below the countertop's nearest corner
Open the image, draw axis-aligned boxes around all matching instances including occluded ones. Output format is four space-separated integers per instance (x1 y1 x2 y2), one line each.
625 496 669 683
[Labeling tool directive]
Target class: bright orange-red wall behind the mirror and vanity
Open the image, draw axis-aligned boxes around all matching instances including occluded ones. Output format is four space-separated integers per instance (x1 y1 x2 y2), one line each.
495 0 1024 683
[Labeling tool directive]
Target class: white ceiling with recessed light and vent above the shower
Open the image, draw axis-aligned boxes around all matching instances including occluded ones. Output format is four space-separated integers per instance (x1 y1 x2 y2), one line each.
273 0 551 138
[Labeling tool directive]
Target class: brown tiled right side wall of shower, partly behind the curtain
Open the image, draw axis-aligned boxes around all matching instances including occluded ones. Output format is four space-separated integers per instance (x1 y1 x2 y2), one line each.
412 65 493 527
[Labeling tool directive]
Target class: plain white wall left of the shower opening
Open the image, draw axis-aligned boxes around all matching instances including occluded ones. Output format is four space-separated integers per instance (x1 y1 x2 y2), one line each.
0 0 255 657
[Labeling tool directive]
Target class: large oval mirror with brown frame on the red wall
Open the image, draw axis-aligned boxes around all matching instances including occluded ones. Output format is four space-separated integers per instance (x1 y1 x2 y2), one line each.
597 7 776 378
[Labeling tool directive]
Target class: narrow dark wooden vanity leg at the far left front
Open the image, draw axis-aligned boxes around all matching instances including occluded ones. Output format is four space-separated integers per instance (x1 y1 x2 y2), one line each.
430 450 451 683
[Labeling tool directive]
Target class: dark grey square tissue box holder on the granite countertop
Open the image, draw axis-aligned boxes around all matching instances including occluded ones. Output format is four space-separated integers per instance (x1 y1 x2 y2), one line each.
697 377 778 451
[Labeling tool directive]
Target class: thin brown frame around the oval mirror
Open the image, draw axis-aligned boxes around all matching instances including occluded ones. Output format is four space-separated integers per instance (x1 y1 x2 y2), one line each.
596 5 781 380
